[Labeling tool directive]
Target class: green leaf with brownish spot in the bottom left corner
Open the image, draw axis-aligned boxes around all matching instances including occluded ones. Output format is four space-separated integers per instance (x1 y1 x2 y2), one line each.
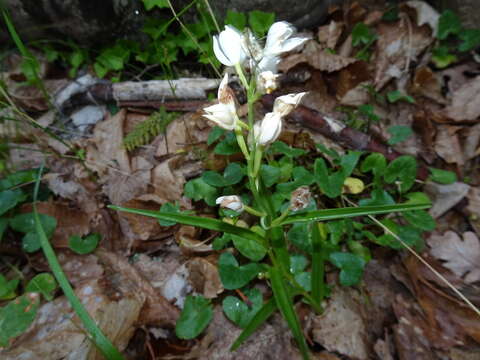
0 294 40 347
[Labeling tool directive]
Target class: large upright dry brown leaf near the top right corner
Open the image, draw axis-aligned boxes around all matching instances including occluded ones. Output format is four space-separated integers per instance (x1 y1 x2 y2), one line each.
374 16 434 90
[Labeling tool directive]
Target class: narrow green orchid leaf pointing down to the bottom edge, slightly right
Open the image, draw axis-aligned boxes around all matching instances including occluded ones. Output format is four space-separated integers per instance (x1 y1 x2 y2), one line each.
268 267 310 360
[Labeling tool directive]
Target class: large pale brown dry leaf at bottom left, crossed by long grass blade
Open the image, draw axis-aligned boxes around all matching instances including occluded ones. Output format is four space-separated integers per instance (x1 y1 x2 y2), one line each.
0 280 145 360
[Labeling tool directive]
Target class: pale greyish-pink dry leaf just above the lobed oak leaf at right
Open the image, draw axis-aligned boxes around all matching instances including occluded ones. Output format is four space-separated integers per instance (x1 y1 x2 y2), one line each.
425 182 470 218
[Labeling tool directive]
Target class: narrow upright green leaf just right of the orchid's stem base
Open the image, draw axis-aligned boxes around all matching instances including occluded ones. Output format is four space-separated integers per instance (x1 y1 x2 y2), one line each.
311 223 326 307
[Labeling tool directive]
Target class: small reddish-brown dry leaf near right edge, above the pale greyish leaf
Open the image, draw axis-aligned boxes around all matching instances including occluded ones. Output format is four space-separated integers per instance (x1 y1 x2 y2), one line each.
434 125 465 165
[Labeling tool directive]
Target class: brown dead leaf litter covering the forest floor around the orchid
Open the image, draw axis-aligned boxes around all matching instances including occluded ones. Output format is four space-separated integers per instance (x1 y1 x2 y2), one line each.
0 1 480 360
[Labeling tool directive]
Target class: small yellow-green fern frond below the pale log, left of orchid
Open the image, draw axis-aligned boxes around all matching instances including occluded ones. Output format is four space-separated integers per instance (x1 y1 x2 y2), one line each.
123 106 179 151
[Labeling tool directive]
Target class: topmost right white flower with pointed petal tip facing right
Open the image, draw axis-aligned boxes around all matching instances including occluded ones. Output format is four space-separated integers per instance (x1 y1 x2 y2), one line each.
263 21 308 57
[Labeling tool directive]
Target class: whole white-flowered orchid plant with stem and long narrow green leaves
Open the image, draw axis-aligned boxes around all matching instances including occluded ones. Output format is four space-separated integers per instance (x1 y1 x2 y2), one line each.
111 21 428 359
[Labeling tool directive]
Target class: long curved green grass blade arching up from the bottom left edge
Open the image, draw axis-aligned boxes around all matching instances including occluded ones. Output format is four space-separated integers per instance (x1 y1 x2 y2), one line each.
33 165 124 360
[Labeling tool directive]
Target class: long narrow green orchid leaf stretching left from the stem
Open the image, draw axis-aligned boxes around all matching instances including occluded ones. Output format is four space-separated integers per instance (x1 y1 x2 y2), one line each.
108 205 265 245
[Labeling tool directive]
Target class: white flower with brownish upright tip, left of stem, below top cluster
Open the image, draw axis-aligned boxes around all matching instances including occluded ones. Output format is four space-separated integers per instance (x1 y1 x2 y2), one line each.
203 74 238 130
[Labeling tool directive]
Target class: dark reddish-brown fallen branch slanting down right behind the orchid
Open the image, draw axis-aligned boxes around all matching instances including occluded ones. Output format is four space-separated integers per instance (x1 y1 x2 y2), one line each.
261 94 429 180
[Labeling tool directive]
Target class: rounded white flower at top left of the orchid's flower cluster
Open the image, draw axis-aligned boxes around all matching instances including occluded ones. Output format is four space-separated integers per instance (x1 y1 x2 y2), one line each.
213 25 247 66
